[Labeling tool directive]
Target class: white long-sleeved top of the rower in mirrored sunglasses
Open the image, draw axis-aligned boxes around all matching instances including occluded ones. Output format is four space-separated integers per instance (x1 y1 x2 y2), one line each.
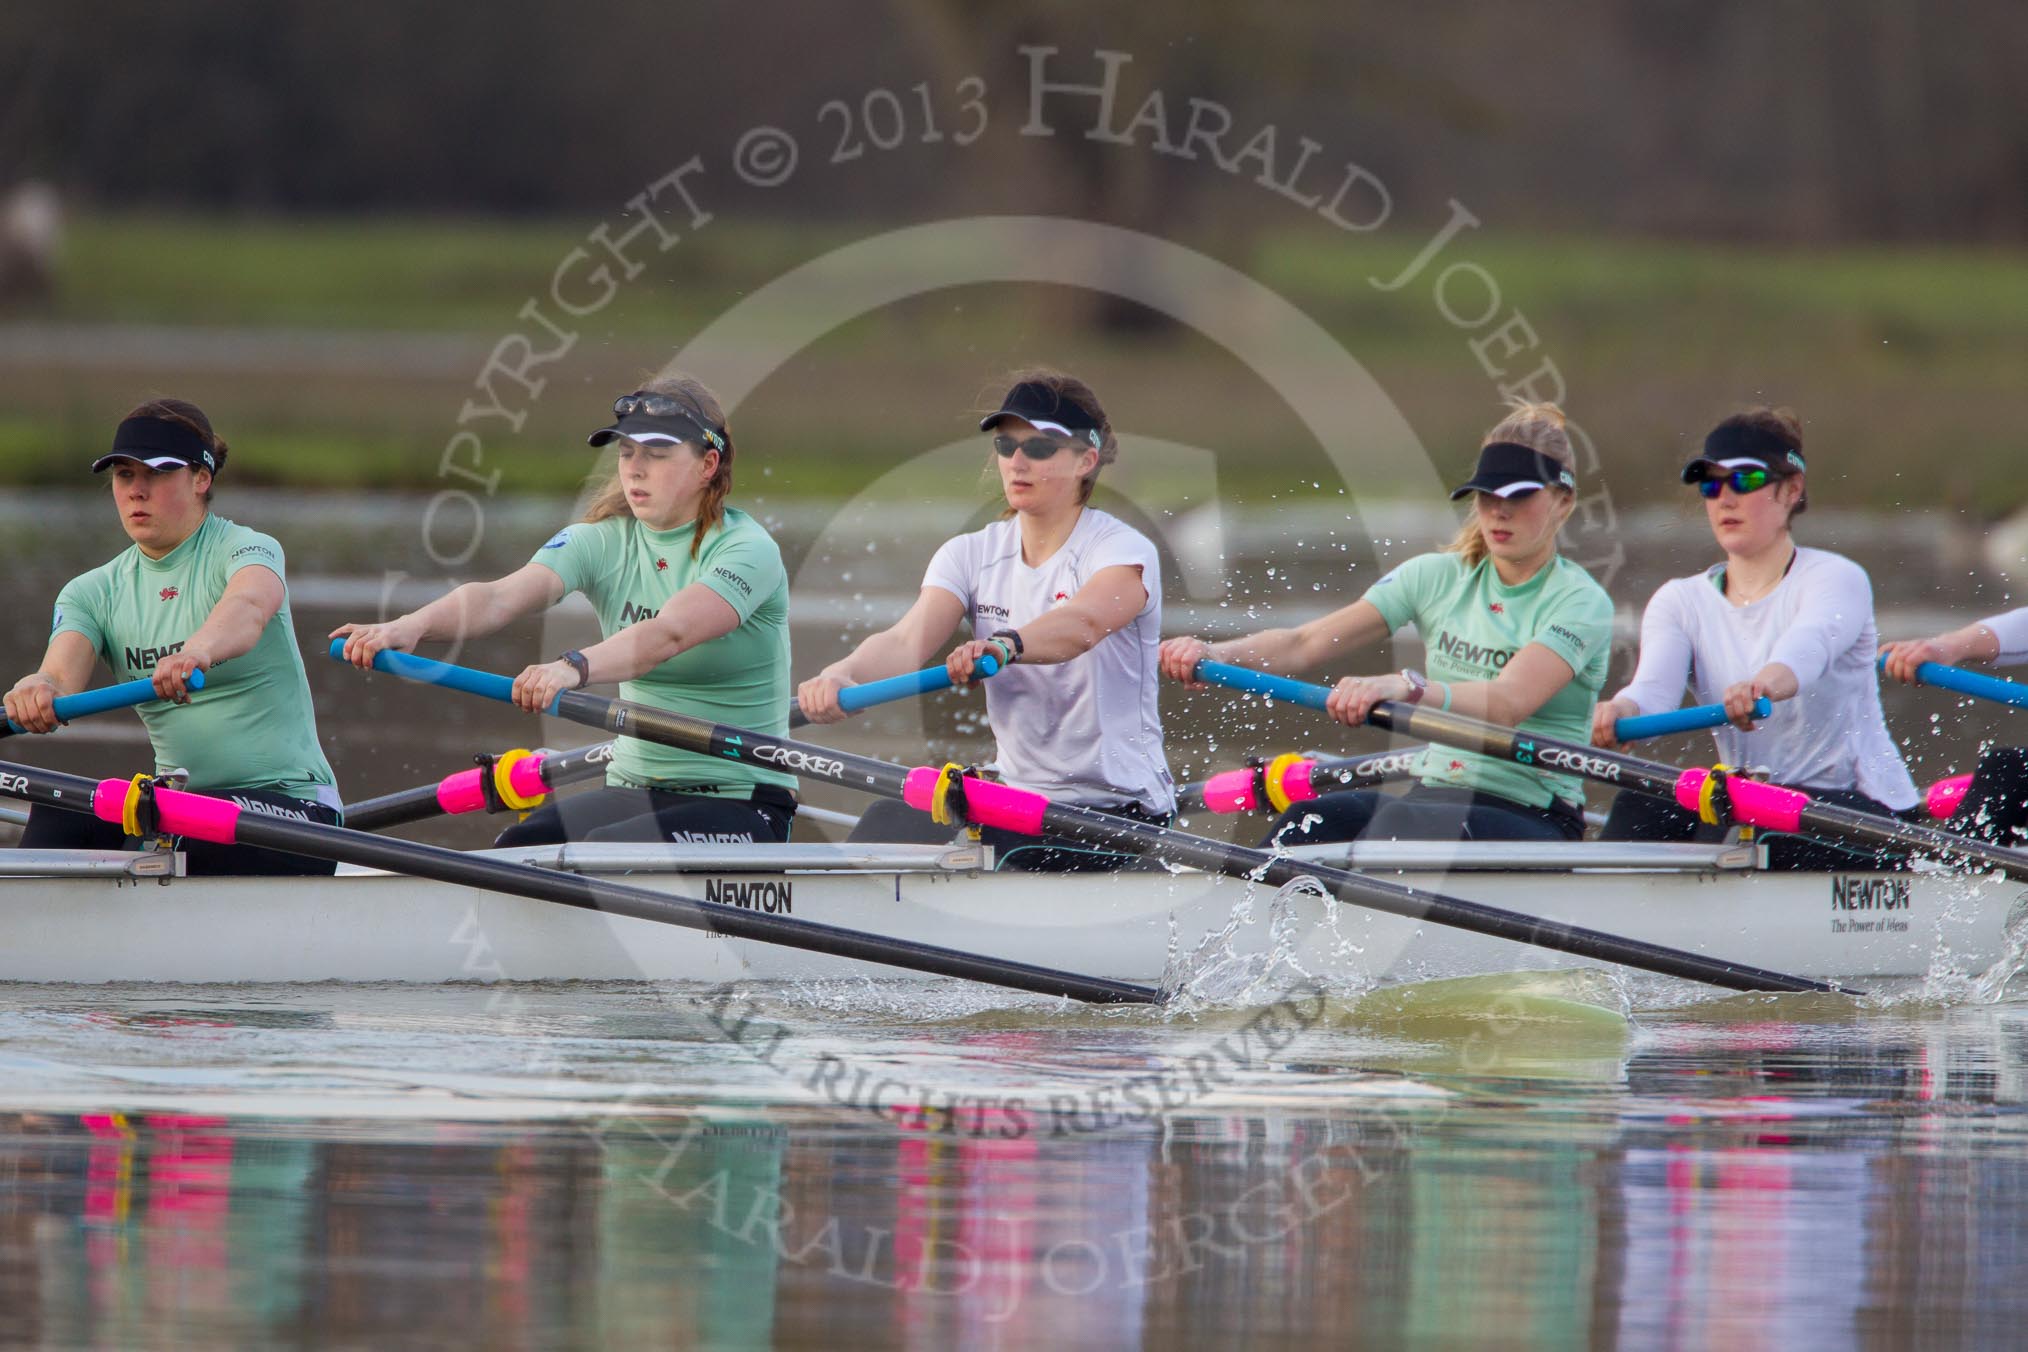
1620 549 1921 811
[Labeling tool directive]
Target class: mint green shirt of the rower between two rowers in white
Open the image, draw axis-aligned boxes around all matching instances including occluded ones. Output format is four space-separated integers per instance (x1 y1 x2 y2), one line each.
1365 553 1612 809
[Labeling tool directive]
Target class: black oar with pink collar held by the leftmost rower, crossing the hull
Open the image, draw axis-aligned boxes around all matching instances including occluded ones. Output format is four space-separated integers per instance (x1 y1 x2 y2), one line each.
0 762 1162 1003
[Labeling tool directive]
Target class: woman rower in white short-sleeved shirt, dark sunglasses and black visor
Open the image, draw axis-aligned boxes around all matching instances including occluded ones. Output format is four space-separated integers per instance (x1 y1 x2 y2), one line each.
797 371 1176 872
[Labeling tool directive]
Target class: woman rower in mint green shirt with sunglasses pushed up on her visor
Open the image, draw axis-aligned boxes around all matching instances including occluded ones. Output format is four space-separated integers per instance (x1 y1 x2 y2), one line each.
333 377 797 845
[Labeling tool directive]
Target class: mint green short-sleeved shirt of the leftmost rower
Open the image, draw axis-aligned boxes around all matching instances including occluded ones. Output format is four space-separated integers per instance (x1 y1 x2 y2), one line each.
49 515 339 807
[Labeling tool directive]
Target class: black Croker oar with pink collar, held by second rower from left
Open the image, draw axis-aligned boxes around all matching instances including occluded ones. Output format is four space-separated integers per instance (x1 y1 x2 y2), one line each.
344 655 1835 991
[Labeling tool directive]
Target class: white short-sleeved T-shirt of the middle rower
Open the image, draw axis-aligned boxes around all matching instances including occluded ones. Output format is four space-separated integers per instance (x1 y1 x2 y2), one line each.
923 507 1176 813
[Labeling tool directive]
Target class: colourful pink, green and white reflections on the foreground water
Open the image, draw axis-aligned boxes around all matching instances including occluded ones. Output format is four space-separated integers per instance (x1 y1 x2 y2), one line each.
0 997 2028 1348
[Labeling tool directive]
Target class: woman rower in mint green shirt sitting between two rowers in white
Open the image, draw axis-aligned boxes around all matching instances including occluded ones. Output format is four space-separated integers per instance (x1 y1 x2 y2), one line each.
1162 403 1612 845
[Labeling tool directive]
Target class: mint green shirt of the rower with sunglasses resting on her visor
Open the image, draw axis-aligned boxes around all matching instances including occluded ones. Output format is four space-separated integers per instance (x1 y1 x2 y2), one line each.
531 507 797 799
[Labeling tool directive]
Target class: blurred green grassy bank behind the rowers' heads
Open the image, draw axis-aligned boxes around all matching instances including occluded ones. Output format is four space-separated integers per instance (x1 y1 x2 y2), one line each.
0 217 2028 515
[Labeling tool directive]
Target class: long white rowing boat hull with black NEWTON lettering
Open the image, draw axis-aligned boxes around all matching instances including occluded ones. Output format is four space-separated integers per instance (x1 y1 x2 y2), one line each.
0 845 2028 983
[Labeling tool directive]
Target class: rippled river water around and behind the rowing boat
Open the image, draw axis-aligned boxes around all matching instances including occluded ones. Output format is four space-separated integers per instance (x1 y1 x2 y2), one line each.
0 495 2028 1348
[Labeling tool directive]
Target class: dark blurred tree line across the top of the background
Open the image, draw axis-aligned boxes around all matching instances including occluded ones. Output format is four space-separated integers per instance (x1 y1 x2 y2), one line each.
0 0 2028 241
